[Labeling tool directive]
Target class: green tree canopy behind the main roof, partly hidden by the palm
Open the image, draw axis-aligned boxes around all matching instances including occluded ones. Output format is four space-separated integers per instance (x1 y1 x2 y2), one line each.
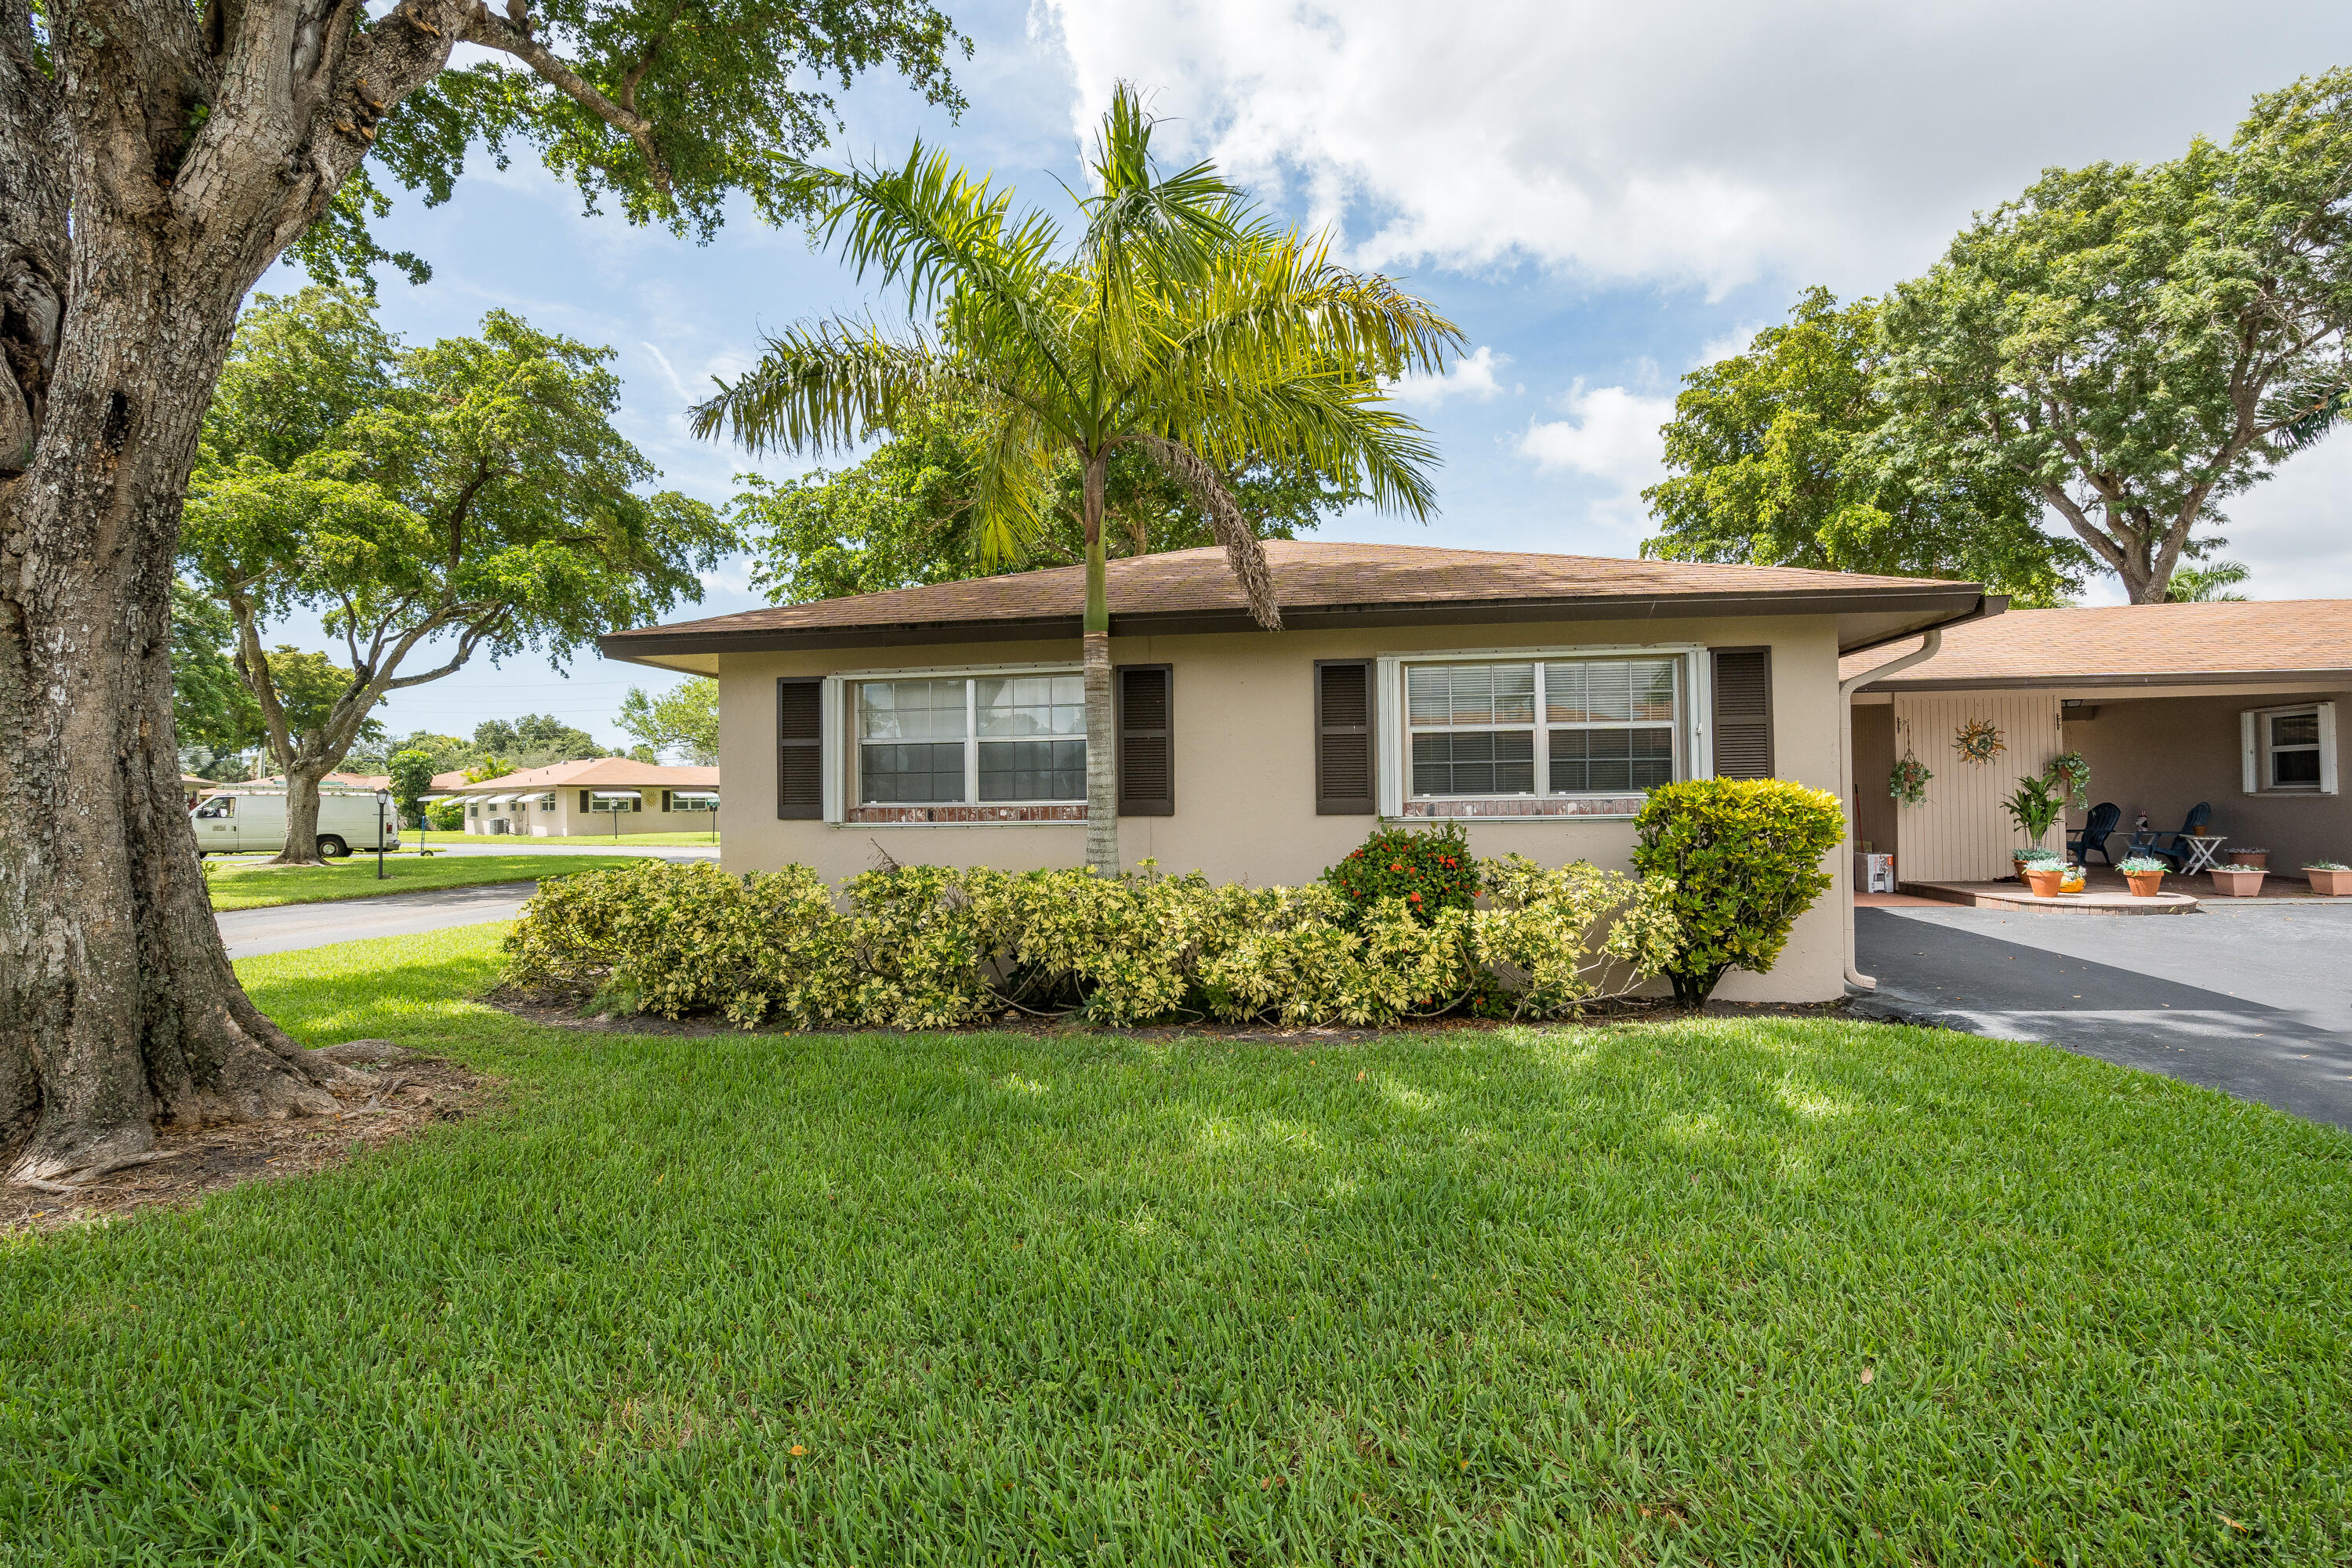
731 395 1364 604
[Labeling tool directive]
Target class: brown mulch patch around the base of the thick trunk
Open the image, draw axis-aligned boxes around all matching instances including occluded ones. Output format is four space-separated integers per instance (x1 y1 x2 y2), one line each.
0 1041 496 1236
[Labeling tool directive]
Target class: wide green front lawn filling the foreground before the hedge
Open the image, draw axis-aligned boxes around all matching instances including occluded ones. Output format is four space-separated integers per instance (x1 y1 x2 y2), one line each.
0 928 2352 1566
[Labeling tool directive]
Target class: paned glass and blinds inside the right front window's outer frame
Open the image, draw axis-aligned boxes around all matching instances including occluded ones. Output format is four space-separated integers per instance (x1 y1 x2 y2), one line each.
1404 659 1682 799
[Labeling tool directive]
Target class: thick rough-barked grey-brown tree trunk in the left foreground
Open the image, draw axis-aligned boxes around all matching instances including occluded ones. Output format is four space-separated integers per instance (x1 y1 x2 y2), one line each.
0 0 485 1178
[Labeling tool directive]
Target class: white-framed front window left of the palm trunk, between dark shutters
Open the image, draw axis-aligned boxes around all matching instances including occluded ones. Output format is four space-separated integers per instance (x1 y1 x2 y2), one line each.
847 670 1087 808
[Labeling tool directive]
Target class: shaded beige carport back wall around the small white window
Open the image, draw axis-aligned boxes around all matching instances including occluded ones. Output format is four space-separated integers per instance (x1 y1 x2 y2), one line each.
2065 691 2352 877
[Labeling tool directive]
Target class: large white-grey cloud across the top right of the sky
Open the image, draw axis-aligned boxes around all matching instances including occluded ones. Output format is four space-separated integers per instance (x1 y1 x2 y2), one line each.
1030 0 2352 292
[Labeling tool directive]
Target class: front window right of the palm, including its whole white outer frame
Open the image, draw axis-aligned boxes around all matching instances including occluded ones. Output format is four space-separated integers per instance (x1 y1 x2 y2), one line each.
1381 647 1703 815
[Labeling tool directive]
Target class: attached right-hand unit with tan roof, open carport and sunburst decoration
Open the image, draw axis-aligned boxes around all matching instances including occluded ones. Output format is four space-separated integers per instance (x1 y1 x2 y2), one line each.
1846 600 2352 881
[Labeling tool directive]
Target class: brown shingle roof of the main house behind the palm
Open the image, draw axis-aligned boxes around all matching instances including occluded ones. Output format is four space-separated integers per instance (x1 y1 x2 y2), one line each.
600 541 1978 659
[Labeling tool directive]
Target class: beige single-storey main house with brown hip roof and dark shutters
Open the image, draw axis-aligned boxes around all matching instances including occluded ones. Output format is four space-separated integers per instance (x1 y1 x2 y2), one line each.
600 543 1990 999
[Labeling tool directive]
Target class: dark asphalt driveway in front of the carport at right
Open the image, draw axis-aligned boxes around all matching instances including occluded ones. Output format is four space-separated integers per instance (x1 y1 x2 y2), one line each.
1853 905 2352 1128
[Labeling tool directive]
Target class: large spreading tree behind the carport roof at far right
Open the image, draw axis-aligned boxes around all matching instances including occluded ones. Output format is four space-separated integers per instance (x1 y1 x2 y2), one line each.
1884 68 2352 604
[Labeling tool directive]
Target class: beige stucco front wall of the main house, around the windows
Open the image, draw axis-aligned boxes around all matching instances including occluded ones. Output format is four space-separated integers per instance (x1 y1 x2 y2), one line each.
720 616 1849 1001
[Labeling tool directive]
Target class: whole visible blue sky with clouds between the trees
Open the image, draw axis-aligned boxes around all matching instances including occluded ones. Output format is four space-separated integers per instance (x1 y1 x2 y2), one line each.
261 0 2352 761
